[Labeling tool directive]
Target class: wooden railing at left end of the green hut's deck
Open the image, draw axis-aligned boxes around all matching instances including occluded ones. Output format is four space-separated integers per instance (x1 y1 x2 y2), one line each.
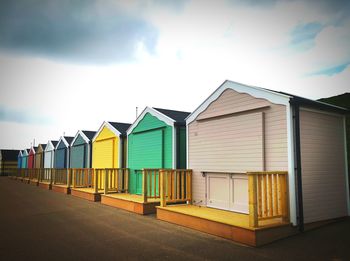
104 168 129 194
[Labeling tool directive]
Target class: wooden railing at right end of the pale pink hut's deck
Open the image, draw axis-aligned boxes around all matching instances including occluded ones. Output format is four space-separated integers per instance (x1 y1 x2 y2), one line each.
247 171 289 227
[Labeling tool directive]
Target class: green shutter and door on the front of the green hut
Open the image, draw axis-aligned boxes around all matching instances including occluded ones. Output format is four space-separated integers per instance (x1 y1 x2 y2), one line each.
129 129 164 194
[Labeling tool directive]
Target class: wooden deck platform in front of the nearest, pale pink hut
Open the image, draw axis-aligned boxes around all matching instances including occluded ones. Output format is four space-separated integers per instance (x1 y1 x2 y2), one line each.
157 205 297 246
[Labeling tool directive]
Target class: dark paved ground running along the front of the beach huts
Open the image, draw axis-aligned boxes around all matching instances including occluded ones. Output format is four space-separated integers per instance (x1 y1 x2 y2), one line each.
0 177 350 260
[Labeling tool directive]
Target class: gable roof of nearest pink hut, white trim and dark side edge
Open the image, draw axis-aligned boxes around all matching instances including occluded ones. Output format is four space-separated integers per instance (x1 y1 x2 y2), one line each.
186 80 348 124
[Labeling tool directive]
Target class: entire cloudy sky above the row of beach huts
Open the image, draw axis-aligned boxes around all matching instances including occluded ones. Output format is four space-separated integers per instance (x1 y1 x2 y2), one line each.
0 0 350 149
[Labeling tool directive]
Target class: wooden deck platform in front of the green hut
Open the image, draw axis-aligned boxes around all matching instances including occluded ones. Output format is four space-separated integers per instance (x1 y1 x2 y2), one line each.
101 193 160 215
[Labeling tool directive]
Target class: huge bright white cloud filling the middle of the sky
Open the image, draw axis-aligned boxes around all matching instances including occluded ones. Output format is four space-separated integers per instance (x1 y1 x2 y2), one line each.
0 1 350 147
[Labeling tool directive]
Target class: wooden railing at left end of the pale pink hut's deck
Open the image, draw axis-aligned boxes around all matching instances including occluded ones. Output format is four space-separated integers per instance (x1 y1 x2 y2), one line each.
160 169 192 207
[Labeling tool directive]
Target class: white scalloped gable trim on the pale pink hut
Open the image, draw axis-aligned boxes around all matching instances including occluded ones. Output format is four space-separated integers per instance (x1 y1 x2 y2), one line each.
186 80 292 125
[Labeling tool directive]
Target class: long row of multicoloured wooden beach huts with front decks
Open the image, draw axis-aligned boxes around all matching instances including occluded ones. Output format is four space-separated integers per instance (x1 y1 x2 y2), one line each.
12 81 350 245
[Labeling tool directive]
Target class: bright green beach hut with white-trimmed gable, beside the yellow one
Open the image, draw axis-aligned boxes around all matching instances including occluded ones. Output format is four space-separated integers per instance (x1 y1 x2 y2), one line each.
127 107 190 194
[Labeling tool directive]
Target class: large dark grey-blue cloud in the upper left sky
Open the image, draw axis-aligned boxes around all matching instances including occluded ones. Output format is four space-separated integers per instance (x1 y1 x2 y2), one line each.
0 0 158 63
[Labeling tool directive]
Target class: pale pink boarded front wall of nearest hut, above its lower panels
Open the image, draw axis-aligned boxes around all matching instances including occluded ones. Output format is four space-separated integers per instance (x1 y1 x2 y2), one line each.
188 89 288 205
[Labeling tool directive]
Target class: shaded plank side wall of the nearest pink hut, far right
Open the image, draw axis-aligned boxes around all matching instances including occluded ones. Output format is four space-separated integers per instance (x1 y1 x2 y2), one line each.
300 110 347 223
